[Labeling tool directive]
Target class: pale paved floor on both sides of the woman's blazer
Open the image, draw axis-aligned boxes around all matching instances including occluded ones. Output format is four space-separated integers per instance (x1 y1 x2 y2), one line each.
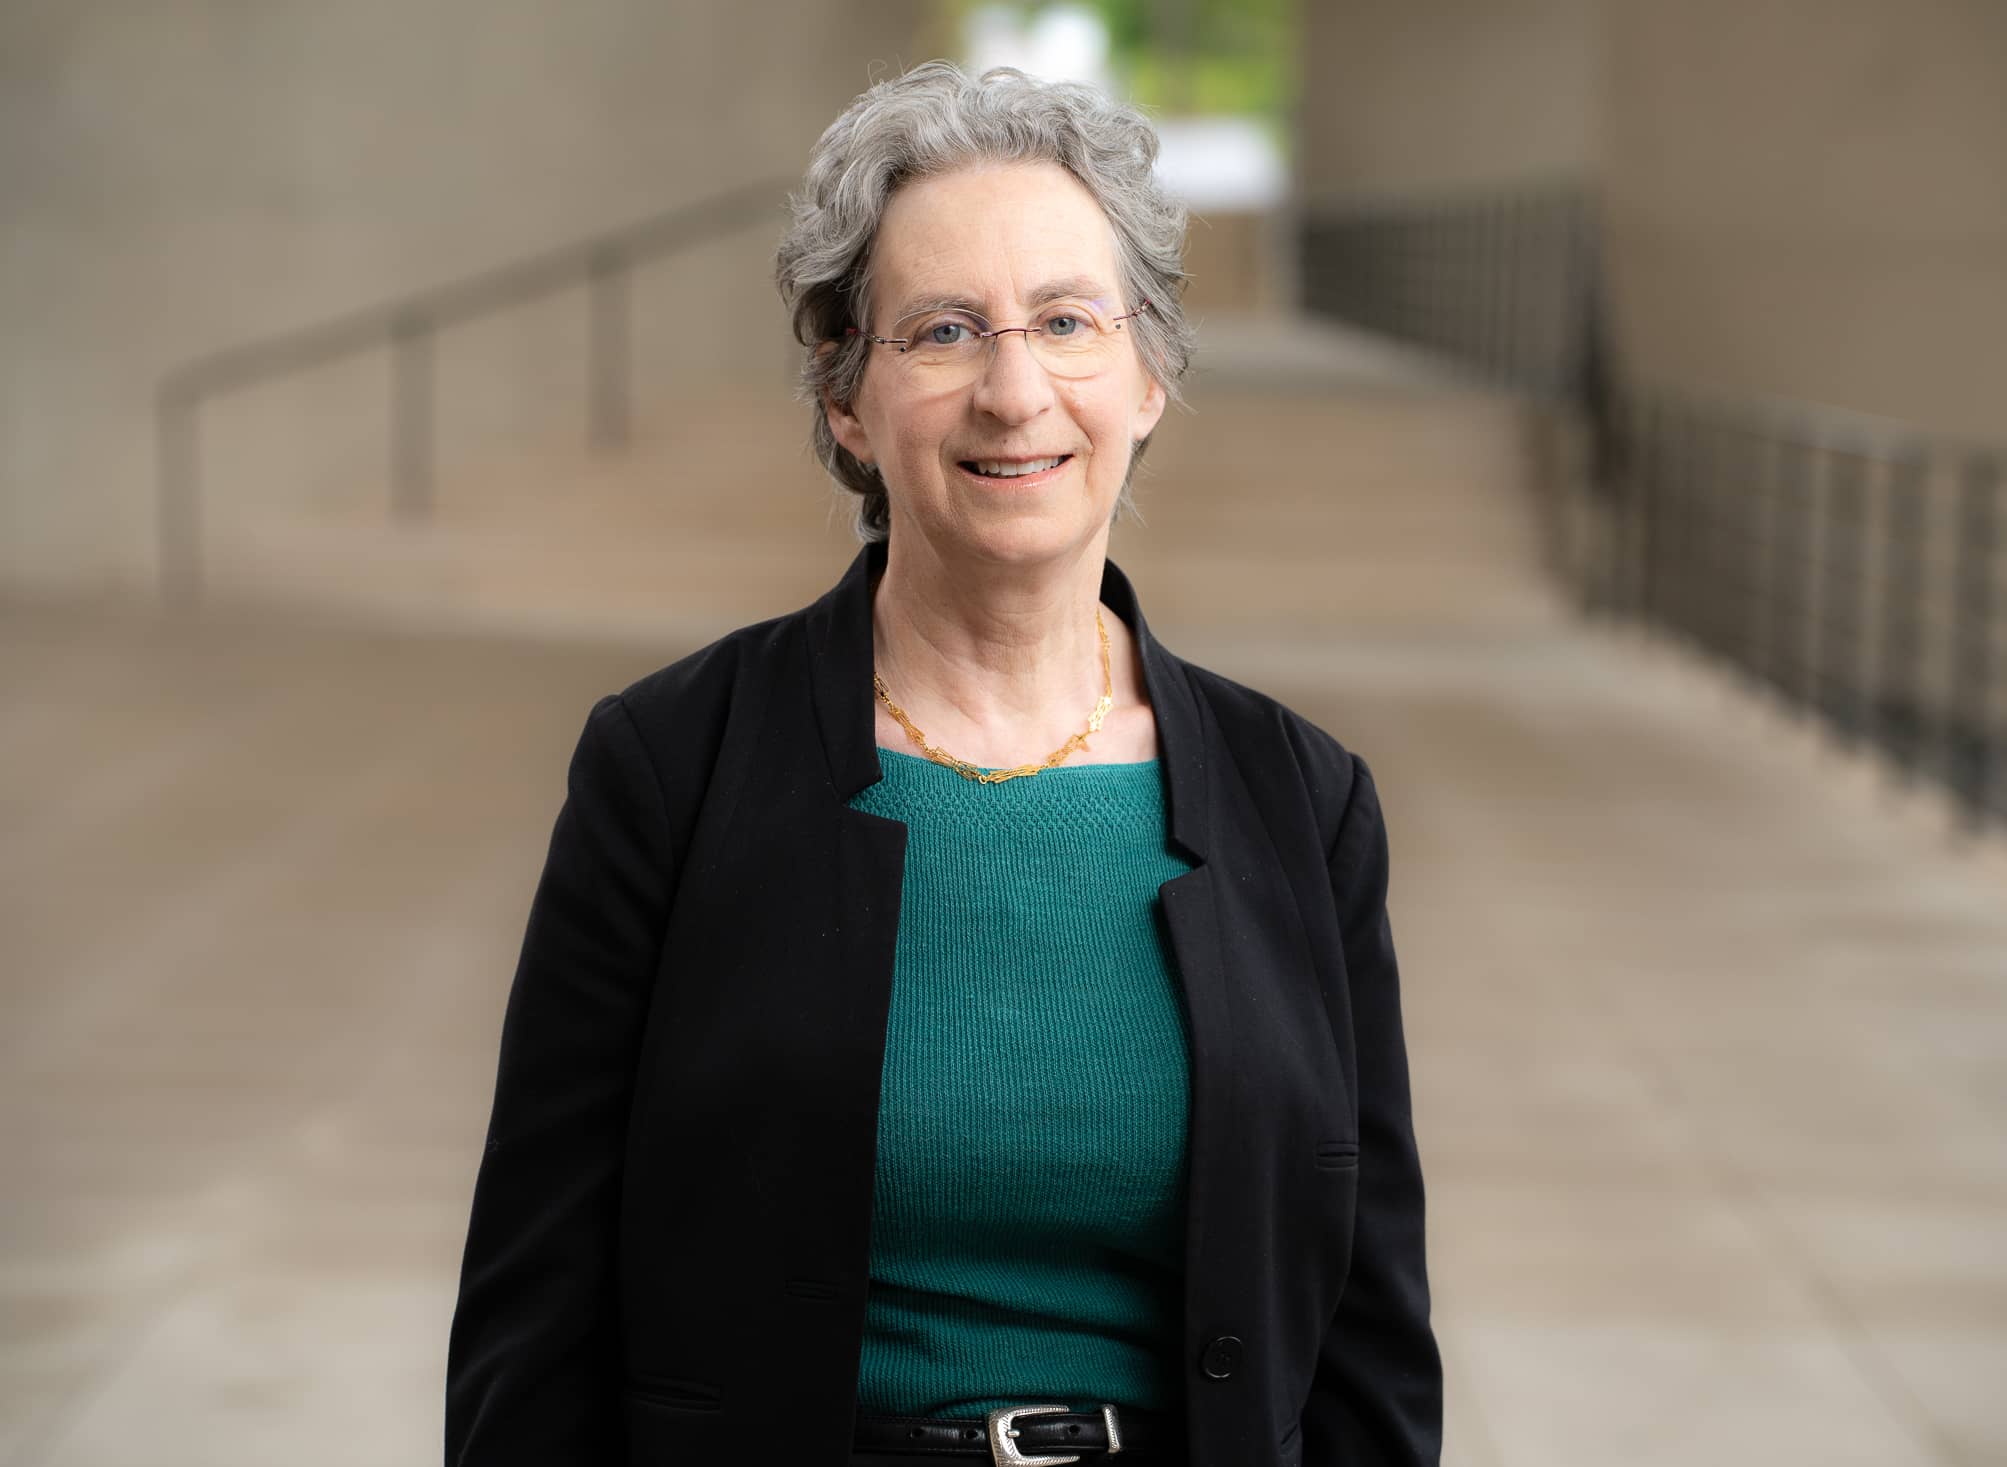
0 582 2007 1467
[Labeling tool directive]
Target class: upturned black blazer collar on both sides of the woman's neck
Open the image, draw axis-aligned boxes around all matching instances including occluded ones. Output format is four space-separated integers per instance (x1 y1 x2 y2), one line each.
809 540 1208 861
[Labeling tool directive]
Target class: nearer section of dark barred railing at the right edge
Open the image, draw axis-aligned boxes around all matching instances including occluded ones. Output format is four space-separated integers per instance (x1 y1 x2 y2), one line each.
1621 389 2007 823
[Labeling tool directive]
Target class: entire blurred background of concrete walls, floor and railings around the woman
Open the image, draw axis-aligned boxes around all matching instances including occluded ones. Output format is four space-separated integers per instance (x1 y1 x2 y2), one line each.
0 0 2007 1467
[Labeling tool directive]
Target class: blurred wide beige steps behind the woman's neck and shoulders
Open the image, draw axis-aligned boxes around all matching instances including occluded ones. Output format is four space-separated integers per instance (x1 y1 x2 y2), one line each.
195 321 1561 642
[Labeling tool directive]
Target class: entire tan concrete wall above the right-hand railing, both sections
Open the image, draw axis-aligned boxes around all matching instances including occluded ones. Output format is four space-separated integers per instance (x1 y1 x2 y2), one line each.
1299 0 2007 442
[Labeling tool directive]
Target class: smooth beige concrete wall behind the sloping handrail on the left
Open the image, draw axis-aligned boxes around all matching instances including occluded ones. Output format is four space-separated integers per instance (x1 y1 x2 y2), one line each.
0 0 925 592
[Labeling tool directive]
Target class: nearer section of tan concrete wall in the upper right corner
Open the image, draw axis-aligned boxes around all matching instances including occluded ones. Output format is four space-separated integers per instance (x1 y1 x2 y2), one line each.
1602 0 2007 439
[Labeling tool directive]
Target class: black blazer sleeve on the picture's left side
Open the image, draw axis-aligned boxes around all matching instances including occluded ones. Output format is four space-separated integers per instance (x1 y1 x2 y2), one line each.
446 694 670 1467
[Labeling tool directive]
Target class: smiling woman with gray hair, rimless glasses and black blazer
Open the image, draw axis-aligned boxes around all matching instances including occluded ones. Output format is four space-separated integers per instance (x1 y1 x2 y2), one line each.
448 62 1441 1467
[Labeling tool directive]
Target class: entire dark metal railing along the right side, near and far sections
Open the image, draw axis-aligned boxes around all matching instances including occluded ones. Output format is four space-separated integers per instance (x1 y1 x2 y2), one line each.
1303 183 2007 821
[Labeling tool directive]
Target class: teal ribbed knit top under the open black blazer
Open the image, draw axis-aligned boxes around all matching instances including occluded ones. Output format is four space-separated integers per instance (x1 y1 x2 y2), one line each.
851 749 1188 1417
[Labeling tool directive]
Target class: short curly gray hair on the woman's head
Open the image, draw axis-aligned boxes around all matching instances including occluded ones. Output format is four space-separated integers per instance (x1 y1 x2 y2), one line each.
775 60 1192 540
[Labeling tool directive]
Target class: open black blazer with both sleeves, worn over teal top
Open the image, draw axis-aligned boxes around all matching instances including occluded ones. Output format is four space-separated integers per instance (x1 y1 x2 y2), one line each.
446 544 1443 1467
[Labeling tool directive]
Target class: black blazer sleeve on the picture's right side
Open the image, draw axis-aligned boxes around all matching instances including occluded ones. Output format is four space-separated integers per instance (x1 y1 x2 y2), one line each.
1303 755 1443 1467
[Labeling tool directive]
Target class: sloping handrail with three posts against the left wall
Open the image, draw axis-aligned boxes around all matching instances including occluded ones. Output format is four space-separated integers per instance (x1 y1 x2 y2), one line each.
155 181 791 606
